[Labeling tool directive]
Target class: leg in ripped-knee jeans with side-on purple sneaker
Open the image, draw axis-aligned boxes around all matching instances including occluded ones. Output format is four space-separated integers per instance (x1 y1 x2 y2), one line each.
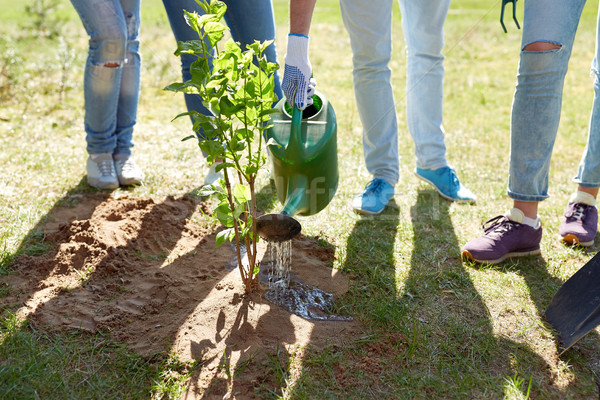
463 0 585 263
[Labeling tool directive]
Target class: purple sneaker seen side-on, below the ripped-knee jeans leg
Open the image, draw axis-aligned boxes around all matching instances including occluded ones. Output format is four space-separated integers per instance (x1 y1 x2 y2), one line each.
462 208 542 264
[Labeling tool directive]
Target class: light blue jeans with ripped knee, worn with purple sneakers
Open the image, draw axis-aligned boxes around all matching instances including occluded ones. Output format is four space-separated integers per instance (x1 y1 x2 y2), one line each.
508 0 600 201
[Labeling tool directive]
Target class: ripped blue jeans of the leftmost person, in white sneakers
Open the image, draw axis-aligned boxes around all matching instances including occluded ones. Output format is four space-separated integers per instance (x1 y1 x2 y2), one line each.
71 0 141 155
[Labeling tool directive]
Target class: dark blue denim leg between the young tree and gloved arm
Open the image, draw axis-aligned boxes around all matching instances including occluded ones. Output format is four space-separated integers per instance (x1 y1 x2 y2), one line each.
224 0 283 99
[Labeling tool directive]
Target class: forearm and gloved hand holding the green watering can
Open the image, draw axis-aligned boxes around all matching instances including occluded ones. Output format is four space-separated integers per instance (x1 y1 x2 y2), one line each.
281 0 316 110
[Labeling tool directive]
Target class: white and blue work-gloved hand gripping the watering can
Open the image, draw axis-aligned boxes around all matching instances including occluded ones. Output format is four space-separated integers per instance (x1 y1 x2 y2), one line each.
281 33 317 110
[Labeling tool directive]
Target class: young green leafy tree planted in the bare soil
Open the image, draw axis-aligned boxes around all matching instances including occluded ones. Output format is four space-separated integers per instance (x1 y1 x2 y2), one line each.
165 0 279 292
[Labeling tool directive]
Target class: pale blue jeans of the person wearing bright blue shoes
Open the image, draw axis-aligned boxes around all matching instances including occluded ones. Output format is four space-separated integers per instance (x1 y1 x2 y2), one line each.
340 0 450 183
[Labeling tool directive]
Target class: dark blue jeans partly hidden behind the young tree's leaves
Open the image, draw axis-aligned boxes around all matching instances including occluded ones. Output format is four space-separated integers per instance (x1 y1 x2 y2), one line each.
163 0 283 136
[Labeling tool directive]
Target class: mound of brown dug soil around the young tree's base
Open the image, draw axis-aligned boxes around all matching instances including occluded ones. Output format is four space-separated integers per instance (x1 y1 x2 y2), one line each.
2 195 356 398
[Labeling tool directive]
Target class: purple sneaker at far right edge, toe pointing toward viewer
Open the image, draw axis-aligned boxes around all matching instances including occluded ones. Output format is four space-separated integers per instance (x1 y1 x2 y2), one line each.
558 201 598 247
